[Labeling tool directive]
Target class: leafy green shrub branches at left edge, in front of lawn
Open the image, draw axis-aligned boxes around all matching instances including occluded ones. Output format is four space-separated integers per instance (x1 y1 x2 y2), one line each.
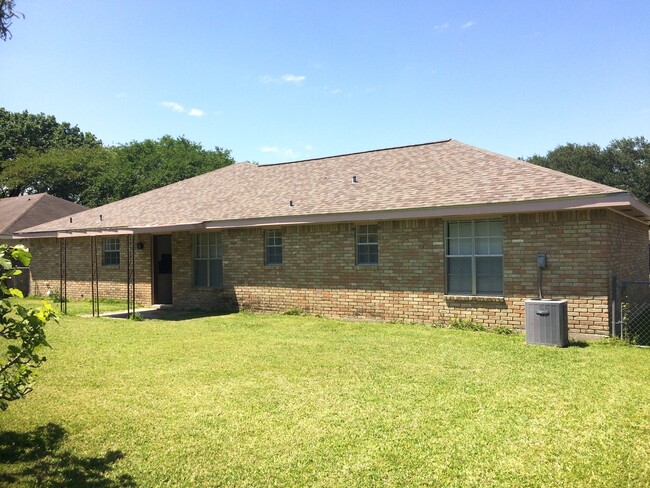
0 244 57 410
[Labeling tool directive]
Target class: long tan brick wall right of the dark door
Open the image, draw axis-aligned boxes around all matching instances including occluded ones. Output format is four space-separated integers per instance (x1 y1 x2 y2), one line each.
168 210 648 335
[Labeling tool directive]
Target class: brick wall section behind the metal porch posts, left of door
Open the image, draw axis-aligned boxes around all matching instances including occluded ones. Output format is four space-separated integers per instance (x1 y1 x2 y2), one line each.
27 235 151 305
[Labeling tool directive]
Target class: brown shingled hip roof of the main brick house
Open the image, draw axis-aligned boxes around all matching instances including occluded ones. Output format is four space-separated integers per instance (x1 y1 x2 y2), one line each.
13 140 650 237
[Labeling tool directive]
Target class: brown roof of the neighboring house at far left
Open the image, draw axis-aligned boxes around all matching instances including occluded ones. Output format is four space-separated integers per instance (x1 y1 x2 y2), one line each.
0 193 88 238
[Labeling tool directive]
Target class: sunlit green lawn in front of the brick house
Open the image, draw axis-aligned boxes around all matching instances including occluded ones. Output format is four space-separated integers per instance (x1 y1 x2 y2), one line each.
0 303 650 487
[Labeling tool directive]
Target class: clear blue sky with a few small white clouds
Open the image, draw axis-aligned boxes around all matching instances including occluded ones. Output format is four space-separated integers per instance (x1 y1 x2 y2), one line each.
0 0 650 163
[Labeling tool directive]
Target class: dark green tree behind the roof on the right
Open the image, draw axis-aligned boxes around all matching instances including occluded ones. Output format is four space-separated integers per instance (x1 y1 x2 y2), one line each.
528 137 650 204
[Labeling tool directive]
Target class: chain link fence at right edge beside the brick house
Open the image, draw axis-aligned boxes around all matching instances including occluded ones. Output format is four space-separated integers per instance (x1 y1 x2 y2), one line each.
620 281 650 346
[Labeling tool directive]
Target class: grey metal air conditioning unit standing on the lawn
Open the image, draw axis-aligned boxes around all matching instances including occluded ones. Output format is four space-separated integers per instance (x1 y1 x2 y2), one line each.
526 300 569 347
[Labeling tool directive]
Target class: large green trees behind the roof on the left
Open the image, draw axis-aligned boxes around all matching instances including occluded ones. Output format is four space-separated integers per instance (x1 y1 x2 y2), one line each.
0 108 234 207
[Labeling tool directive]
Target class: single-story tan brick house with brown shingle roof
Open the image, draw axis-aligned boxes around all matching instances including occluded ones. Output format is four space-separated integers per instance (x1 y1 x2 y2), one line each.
15 140 650 336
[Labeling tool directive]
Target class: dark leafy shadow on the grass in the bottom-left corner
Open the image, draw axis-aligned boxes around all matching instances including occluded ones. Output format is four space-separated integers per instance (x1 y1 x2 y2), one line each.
0 423 136 488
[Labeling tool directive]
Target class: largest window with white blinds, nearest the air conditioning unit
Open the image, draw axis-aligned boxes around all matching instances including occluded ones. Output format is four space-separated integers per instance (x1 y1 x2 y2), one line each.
446 220 503 295
